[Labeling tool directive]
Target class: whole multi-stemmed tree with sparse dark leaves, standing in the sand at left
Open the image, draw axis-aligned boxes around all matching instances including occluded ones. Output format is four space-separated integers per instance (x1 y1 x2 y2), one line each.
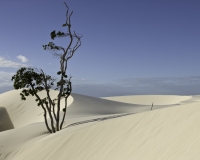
12 2 82 133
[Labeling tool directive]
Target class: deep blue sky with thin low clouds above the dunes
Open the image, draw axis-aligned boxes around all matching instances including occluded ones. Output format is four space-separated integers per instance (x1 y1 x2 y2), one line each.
0 0 200 96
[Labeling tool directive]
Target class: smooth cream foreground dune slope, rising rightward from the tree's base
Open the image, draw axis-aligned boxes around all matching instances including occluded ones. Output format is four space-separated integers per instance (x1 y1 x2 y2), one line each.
5 102 200 160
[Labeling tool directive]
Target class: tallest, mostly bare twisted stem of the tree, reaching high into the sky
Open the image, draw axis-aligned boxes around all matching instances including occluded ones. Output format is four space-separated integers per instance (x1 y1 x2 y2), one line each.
38 2 82 131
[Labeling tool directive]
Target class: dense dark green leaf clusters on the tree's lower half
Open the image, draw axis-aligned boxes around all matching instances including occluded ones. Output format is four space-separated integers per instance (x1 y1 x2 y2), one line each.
11 67 71 106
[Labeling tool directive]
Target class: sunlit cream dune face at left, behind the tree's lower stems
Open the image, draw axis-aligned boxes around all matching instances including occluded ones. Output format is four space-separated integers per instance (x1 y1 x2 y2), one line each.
0 90 73 128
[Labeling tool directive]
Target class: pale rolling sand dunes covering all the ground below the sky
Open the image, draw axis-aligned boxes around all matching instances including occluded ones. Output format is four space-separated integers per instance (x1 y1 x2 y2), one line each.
0 90 200 160
